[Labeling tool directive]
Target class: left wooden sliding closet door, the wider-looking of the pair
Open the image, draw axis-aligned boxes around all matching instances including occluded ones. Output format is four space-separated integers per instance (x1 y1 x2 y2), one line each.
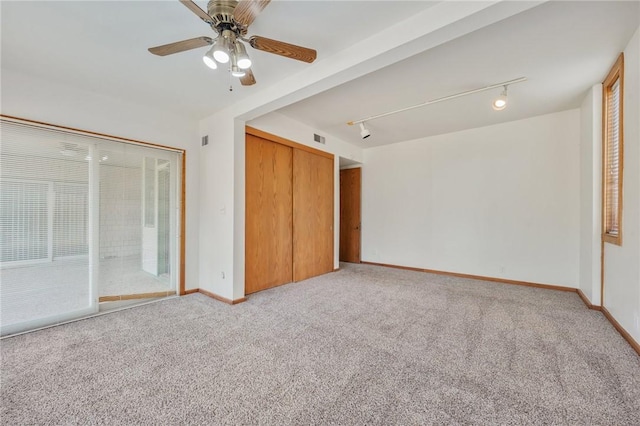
245 135 293 294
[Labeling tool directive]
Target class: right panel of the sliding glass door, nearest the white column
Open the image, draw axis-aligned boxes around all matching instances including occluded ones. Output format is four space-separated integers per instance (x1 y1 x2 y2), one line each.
98 144 178 302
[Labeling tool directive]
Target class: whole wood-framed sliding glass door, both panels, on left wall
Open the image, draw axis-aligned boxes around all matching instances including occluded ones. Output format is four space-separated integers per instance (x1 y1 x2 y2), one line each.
0 119 181 335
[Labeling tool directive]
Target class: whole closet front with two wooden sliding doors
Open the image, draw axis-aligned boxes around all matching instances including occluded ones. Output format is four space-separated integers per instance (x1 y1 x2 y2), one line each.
245 127 334 294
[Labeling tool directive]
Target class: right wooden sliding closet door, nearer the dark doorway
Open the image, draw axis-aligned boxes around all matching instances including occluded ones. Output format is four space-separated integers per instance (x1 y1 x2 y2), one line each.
293 149 333 281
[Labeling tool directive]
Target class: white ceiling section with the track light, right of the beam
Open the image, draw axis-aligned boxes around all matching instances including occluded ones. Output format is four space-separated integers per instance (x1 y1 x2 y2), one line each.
279 1 640 147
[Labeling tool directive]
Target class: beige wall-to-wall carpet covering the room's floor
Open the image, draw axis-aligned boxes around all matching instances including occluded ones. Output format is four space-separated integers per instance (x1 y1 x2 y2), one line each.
1 264 640 425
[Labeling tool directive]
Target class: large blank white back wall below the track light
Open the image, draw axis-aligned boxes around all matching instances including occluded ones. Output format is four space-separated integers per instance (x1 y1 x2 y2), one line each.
362 110 580 287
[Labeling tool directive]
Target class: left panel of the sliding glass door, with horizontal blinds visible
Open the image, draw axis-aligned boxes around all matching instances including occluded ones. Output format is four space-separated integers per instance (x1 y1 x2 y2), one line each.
0 120 93 334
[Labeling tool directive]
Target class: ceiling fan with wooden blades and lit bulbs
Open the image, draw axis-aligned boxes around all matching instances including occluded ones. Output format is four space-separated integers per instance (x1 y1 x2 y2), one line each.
149 0 317 86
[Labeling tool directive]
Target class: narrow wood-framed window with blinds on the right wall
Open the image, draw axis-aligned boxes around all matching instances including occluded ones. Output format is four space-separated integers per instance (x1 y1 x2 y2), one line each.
602 54 624 245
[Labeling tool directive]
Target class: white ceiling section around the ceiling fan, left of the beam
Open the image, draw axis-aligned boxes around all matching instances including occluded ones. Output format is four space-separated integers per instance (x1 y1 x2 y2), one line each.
0 0 436 119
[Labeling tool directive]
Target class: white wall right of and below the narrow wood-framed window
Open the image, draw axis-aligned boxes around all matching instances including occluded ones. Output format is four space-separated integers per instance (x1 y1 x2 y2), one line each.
604 30 640 342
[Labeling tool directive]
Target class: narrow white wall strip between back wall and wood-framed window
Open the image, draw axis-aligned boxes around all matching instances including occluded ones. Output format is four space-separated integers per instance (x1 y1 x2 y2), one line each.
579 84 602 305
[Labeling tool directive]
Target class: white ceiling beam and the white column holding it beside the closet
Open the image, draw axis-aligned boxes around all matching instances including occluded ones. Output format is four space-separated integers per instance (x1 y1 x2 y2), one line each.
192 2 537 299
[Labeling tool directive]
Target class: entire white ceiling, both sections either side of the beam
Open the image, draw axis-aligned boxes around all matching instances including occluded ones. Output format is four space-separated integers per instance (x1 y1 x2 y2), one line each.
0 0 640 147
